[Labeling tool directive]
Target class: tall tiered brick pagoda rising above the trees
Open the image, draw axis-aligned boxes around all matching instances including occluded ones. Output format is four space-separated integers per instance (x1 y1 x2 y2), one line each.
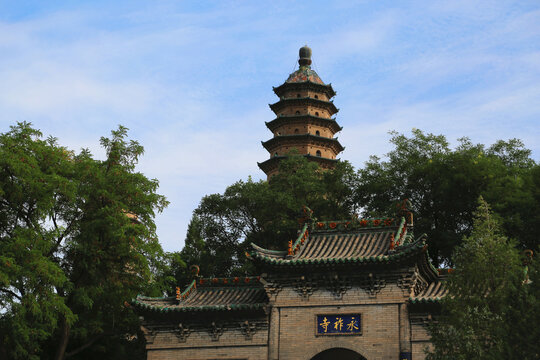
258 46 344 178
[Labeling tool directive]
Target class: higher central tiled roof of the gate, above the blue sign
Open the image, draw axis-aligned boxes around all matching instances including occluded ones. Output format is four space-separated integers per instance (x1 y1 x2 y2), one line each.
250 219 426 265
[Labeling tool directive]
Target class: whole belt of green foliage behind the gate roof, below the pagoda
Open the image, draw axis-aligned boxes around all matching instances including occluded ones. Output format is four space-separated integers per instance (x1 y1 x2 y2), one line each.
178 130 540 283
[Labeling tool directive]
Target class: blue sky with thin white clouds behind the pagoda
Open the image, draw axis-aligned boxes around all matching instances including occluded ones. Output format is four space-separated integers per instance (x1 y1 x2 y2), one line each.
0 0 540 251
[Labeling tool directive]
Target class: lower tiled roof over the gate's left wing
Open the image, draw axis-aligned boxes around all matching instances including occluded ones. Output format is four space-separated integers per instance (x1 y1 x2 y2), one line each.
131 277 268 312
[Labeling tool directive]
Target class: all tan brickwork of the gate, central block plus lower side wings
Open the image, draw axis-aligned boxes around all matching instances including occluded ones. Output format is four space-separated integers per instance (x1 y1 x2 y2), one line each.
143 284 429 360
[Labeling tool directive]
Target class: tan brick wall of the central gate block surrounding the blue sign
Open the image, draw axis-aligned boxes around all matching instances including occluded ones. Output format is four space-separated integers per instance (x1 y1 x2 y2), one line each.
270 284 412 360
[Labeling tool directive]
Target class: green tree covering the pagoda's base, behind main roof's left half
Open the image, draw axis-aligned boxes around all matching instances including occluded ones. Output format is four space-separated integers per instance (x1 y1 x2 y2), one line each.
179 154 356 282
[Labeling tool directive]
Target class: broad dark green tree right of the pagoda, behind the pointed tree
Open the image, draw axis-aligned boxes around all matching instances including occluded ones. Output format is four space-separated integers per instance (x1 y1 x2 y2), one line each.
356 130 539 264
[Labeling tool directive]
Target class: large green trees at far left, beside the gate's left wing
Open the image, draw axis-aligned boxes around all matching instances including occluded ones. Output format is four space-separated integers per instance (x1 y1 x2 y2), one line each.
0 123 167 359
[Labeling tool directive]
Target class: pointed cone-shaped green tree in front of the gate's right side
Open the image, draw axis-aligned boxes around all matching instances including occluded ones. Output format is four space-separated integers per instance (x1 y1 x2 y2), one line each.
427 198 540 360
